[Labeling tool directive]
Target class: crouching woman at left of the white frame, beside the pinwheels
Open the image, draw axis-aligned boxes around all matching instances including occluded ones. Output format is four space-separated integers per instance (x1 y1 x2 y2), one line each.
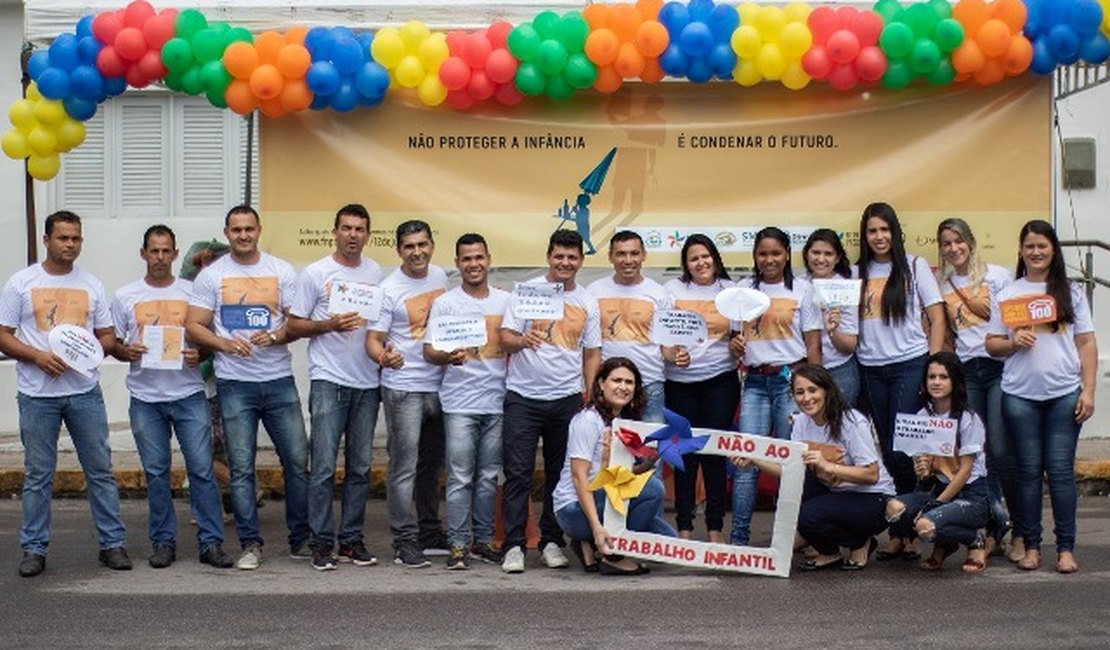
552 356 675 576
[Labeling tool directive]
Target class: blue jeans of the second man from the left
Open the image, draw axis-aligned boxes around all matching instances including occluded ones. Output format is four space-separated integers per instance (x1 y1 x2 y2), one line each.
130 390 223 553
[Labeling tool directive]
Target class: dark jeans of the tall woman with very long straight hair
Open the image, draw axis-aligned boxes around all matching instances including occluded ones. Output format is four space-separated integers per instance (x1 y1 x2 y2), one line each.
859 354 929 495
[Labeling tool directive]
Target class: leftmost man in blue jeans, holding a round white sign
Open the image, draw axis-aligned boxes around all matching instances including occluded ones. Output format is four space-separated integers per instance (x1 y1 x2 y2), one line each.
0 211 131 578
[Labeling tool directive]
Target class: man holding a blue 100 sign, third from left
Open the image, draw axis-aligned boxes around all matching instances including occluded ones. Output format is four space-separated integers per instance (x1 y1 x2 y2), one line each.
185 205 312 570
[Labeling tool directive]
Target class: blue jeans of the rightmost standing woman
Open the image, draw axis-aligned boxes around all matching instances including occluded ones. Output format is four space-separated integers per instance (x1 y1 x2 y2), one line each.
1002 389 1081 552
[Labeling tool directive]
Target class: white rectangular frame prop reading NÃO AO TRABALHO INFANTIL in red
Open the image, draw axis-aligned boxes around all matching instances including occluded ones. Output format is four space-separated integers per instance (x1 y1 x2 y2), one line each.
605 419 806 578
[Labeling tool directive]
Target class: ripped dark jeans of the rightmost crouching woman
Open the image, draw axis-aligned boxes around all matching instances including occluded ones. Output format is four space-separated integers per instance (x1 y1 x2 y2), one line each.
890 478 990 548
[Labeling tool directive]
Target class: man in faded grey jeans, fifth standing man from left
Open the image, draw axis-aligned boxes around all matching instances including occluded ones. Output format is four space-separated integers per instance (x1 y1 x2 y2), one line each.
366 220 447 569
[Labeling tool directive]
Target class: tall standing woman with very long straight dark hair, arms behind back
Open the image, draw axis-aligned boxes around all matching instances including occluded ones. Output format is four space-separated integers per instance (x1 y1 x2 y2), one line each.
856 203 945 559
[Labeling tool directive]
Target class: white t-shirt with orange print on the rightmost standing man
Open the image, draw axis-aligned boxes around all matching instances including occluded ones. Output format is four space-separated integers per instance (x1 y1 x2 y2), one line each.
588 276 670 384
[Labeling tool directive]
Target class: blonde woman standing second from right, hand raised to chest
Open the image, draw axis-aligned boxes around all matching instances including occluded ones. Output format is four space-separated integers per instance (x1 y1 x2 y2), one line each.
937 217 1026 558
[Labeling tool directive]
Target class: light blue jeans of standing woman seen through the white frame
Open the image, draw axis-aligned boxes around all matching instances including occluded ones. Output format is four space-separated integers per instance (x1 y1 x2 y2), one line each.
728 366 795 546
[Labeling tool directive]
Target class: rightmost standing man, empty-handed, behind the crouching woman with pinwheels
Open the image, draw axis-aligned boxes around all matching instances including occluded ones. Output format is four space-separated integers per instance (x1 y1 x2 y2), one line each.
589 231 672 423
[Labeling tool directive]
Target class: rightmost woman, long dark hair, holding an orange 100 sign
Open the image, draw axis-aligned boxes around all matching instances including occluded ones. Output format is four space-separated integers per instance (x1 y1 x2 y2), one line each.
987 220 1098 573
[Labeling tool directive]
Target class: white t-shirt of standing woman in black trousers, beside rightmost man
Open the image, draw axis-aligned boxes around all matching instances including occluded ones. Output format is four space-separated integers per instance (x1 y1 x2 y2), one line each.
663 278 739 384
